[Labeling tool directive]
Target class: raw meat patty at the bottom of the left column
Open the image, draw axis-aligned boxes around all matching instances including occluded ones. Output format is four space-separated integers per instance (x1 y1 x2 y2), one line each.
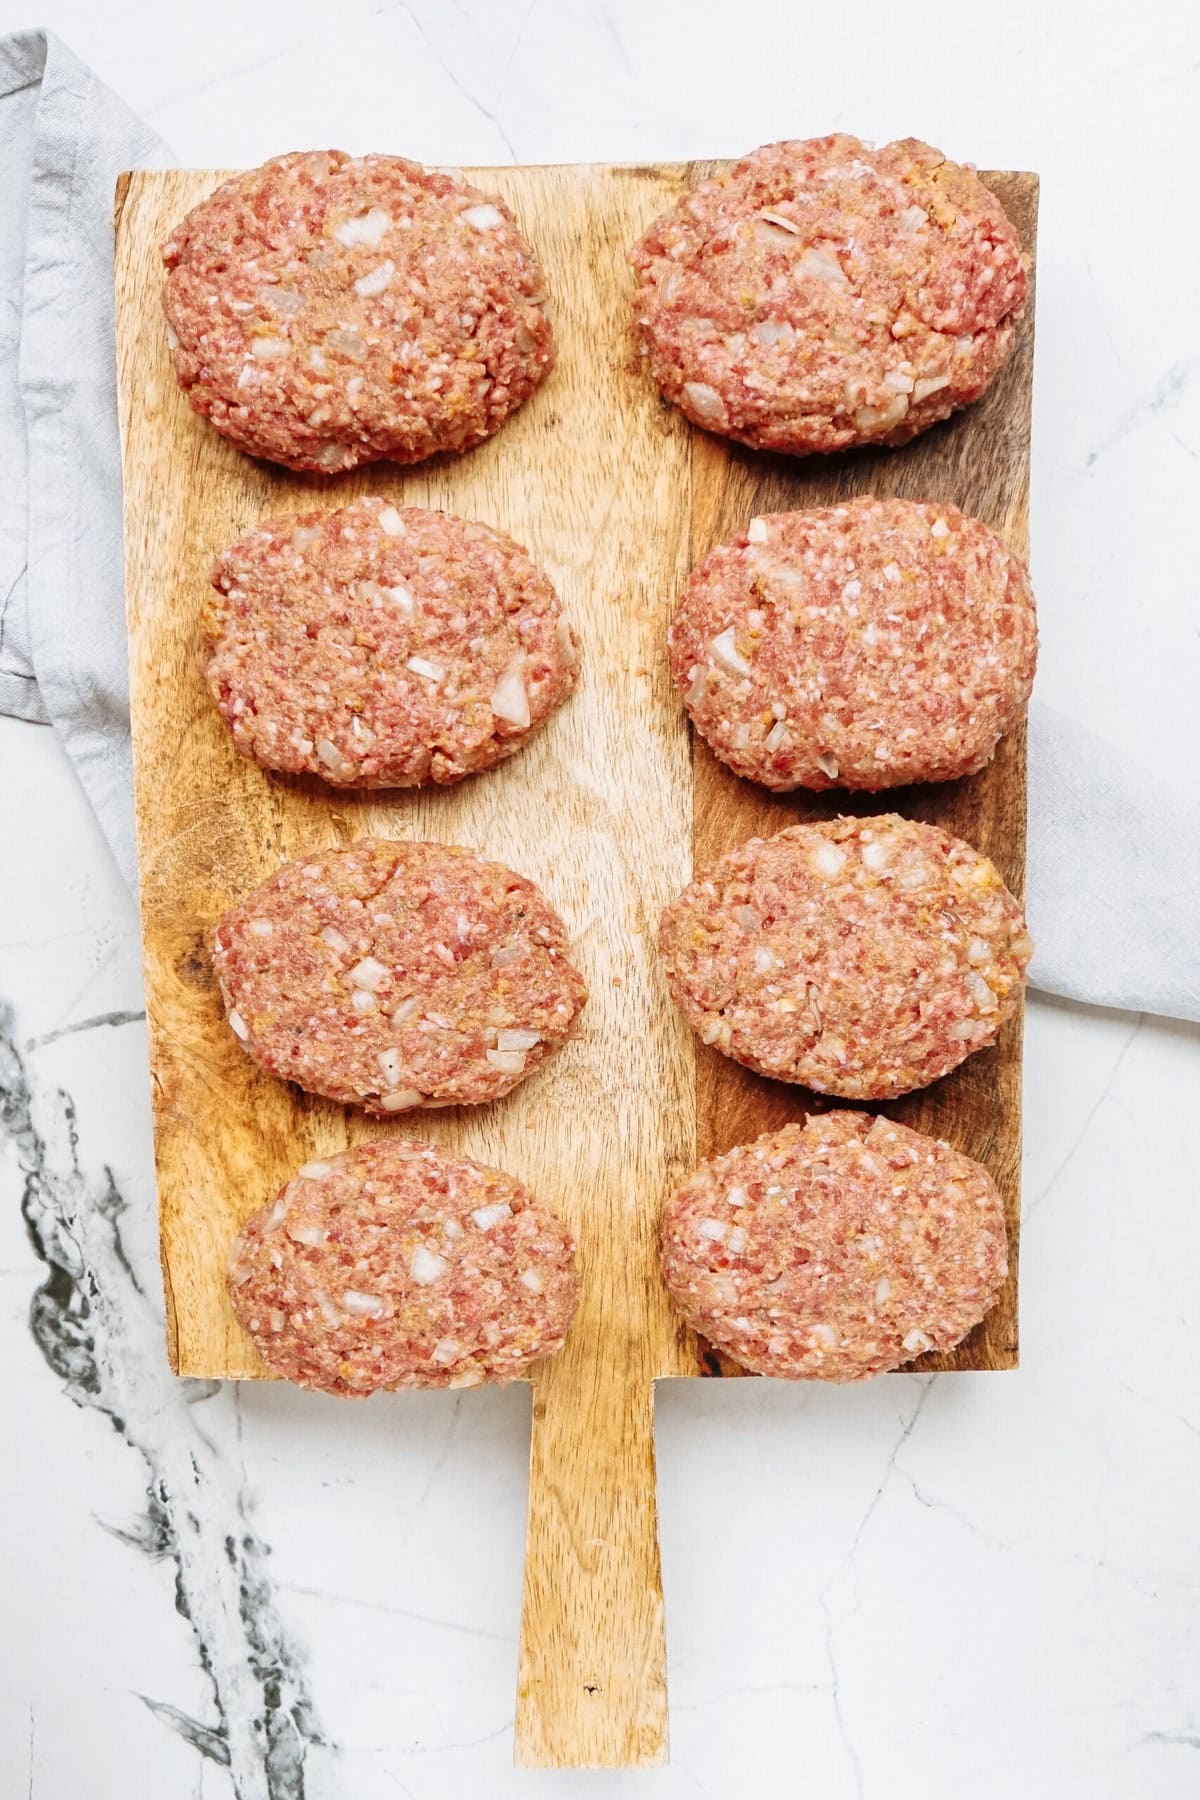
228 1138 579 1397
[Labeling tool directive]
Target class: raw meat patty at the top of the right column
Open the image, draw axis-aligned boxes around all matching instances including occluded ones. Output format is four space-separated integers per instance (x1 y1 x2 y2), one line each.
630 135 1029 452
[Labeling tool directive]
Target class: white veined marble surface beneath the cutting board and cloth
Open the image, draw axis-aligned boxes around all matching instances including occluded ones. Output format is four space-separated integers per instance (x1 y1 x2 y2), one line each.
0 0 1200 1800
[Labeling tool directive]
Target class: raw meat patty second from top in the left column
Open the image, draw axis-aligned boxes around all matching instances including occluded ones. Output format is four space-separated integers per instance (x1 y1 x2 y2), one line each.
201 499 578 787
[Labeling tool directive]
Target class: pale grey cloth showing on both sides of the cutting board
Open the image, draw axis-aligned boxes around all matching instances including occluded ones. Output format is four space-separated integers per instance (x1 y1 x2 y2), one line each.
0 32 1200 1019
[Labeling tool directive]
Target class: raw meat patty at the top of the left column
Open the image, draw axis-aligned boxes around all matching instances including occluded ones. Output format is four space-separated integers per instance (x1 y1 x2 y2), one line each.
162 149 554 472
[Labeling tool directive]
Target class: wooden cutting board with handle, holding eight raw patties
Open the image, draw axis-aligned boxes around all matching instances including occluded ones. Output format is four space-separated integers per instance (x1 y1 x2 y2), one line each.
117 164 1038 1768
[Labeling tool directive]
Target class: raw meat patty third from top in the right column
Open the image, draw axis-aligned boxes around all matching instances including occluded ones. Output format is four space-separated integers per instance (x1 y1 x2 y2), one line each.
658 814 1033 1100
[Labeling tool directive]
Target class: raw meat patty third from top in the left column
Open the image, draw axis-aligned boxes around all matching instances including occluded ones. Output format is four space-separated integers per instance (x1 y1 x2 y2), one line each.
212 839 587 1112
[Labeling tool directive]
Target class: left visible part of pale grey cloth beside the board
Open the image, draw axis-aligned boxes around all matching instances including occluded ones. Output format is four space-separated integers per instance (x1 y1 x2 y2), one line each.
0 31 175 886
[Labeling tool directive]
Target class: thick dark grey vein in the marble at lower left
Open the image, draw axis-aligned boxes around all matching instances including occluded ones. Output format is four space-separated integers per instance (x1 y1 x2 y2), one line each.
0 1006 326 1800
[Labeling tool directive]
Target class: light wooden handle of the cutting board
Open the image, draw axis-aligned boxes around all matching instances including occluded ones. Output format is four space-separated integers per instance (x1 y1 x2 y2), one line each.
515 1346 667 1769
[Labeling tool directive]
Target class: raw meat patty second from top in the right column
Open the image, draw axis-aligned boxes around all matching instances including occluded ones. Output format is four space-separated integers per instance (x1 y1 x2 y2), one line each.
669 497 1038 790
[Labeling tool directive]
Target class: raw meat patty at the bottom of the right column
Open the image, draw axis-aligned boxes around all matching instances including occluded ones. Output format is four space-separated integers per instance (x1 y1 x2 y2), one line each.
662 1112 1007 1381
